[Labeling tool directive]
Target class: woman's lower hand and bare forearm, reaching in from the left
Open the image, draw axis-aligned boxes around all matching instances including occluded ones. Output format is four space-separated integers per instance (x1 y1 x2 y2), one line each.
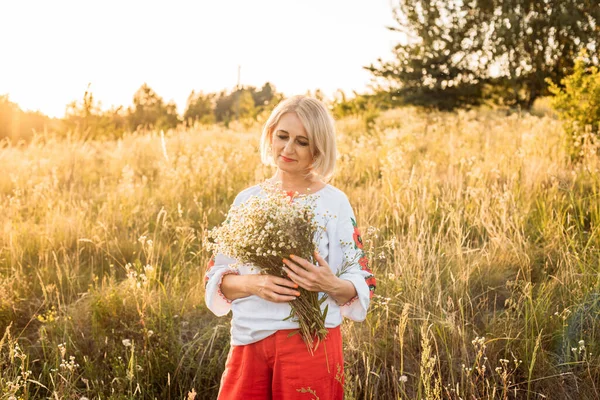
221 274 300 303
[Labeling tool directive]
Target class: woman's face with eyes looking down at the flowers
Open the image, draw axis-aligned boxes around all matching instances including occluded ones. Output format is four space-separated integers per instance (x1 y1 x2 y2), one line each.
272 112 313 174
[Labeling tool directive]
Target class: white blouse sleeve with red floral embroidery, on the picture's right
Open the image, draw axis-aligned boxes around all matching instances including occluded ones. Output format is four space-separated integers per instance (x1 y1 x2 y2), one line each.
336 198 376 321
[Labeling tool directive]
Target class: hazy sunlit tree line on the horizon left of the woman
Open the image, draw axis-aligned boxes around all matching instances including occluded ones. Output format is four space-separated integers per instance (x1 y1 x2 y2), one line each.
0 82 283 140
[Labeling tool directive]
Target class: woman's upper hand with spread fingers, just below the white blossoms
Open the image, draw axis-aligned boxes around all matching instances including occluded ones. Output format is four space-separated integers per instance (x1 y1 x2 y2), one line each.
283 251 341 293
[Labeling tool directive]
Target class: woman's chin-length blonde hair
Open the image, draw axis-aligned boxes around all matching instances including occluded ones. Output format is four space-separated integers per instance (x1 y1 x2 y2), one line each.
260 96 337 182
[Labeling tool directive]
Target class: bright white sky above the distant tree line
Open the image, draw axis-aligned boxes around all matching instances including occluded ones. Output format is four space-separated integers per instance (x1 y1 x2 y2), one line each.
0 0 399 117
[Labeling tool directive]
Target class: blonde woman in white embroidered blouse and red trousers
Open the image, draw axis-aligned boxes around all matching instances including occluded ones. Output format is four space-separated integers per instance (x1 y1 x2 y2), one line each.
206 96 375 399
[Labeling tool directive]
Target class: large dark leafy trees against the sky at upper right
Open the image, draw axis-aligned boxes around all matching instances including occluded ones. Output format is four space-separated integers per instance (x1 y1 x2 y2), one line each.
366 0 600 108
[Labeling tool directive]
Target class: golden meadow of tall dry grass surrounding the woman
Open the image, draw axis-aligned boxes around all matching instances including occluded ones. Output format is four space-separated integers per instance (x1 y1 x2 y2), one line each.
0 108 600 400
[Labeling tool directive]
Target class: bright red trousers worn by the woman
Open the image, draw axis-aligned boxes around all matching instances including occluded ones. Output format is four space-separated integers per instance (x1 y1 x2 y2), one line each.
218 326 344 400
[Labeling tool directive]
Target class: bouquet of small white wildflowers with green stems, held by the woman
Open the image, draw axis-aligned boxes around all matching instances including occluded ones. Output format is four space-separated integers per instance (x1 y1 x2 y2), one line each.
208 183 327 352
